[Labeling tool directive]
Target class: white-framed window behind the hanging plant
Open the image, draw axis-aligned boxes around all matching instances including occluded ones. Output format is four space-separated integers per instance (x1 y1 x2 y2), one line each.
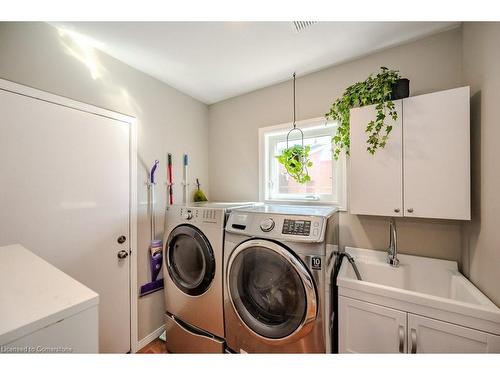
259 119 345 207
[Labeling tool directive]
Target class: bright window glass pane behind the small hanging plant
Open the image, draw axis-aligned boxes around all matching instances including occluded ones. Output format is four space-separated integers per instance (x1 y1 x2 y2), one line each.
274 135 333 195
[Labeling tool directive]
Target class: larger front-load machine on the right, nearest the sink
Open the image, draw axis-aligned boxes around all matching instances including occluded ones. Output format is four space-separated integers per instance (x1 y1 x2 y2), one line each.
224 205 338 353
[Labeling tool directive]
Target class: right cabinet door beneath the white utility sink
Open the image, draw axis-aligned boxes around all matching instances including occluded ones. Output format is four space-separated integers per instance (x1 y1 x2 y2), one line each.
408 314 500 353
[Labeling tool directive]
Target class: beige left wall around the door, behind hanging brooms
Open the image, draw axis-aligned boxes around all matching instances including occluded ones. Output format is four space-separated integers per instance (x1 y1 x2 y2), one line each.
0 22 208 339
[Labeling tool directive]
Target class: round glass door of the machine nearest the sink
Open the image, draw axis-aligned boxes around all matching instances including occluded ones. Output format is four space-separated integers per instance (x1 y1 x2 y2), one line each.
226 239 318 342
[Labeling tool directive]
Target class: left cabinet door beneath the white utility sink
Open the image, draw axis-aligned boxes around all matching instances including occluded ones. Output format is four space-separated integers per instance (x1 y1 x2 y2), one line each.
339 296 407 353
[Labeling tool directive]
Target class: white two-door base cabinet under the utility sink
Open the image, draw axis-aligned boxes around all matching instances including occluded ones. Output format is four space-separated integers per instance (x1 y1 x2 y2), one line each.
338 296 500 353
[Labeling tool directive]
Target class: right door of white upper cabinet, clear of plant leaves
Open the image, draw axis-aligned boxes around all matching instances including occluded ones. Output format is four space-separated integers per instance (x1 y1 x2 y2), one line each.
403 87 470 220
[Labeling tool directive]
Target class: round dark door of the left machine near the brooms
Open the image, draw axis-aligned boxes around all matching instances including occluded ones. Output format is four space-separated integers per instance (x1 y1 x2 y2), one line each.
165 224 215 296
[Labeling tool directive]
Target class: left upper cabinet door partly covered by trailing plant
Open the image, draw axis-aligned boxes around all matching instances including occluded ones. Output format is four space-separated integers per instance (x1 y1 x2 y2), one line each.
349 100 403 216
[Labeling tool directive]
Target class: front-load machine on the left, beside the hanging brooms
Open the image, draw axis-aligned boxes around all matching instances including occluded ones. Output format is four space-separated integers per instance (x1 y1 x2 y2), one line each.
163 202 254 353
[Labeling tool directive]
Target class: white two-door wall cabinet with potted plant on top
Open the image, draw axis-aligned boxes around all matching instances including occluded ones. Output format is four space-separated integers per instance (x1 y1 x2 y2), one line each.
349 87 470 220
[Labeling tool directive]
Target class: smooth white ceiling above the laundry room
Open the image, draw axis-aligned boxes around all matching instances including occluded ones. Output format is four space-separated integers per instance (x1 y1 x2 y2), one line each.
53 22 459 104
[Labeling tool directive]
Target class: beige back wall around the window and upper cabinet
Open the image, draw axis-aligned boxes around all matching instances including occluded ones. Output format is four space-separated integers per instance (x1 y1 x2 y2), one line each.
209 29 462 260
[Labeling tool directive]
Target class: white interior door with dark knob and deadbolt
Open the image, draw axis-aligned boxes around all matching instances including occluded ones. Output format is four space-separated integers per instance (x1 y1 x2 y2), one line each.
0 90 131 353
